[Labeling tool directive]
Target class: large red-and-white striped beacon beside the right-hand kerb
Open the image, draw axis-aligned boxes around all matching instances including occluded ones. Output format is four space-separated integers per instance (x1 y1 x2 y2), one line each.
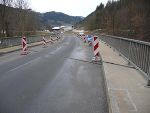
93 36 100 61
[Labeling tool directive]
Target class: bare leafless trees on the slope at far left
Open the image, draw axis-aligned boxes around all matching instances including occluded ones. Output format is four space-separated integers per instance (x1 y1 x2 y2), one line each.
0 0 41 37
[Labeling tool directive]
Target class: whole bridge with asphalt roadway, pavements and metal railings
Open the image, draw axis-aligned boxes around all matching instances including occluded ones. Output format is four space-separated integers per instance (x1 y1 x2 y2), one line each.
0 32 150 113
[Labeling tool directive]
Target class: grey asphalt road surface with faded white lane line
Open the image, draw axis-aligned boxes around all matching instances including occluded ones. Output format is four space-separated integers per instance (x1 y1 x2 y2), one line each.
0 34 108 113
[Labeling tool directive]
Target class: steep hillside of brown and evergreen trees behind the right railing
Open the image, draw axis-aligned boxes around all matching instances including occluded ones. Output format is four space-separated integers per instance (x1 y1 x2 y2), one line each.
78 0 150 41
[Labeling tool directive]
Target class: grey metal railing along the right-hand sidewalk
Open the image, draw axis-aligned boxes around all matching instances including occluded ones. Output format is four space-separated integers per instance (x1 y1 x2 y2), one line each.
99 35 150 86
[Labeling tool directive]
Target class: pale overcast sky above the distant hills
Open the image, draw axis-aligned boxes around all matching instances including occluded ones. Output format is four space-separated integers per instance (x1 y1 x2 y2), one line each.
29 0 108 17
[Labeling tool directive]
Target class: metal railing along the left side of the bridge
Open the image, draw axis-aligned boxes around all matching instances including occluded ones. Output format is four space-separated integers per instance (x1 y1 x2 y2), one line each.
0 33 59 48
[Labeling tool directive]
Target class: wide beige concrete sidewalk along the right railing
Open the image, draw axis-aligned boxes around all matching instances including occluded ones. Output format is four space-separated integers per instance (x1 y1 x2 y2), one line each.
100 42 150 113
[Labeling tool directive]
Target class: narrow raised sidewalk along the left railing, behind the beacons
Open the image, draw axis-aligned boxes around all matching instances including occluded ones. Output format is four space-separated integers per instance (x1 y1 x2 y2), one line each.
0 39 57 55
